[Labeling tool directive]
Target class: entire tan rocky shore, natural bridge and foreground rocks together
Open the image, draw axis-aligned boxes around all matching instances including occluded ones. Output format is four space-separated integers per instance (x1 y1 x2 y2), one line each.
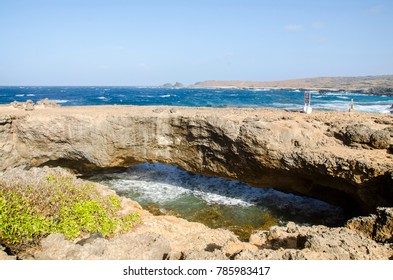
0 106 393 259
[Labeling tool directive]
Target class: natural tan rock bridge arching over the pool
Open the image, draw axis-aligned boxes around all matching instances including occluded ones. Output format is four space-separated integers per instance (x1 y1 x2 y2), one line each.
0 106 393 213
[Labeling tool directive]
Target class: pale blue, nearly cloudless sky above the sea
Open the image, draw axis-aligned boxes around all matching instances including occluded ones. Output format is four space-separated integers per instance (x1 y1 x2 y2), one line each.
0 0 393 86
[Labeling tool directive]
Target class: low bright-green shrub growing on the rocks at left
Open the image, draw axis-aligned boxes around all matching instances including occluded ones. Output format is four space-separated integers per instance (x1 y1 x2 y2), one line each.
0 171 140 254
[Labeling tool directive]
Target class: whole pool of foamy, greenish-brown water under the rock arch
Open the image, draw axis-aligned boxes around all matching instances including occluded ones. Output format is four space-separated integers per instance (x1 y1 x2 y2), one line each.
90 163 344 238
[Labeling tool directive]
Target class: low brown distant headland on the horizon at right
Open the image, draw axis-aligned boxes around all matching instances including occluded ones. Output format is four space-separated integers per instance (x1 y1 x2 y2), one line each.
191 75 393 94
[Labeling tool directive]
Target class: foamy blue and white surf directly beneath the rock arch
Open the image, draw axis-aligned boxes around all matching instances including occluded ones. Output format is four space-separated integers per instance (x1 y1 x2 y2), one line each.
98 164 341 214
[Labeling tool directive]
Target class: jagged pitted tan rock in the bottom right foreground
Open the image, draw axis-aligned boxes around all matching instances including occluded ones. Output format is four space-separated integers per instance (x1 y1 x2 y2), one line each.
240 225 393 260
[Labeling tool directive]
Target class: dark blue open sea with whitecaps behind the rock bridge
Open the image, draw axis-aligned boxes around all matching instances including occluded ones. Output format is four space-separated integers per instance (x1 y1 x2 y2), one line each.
0 87 393 113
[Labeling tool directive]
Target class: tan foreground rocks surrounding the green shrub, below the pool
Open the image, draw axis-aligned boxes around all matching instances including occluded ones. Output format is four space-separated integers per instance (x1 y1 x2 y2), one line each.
0 167 393 260
